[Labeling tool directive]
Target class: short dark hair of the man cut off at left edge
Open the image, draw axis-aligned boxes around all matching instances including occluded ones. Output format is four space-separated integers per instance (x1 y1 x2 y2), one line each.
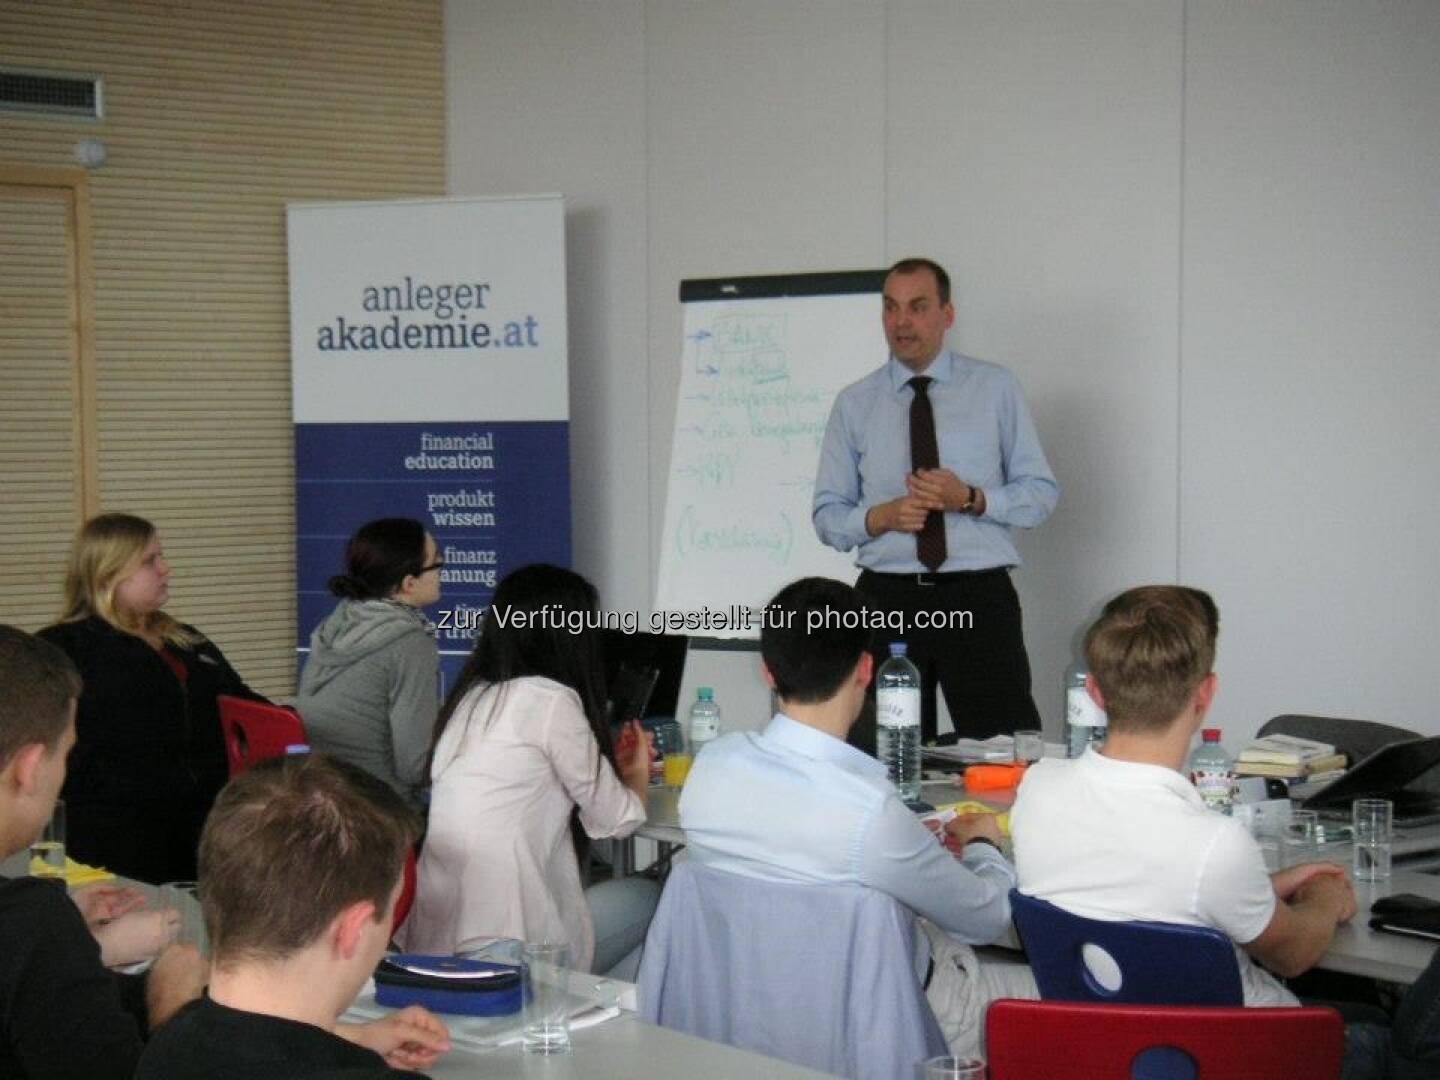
0 626 81 768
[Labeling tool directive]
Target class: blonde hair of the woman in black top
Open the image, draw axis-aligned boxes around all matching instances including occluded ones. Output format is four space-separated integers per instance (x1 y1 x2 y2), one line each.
60 514 200 648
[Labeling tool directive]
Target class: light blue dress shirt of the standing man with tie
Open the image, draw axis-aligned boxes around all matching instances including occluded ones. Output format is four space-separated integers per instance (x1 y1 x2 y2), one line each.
814 350 1060 573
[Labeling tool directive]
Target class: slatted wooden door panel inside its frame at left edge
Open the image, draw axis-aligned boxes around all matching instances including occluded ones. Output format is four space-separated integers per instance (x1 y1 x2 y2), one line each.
0 184 79 631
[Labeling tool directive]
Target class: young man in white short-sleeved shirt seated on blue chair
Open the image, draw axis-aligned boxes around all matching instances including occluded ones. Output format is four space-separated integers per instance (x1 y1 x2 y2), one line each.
1011 586 1355 1005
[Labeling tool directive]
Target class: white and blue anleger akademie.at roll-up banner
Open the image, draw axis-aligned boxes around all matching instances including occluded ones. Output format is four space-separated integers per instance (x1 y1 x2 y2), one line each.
288 196 570 687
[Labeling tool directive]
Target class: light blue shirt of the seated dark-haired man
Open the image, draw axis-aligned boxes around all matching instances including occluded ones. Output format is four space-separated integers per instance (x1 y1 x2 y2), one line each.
680 713 1015 945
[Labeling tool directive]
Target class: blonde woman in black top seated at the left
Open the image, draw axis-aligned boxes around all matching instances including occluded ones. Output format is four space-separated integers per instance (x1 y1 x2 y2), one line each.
40 514 264 883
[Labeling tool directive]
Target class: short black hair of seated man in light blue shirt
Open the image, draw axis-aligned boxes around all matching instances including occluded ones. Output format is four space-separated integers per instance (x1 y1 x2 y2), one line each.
760 577 870 704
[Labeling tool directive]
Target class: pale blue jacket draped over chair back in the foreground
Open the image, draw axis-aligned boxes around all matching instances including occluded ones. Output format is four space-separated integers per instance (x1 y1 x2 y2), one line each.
639 861 946 1080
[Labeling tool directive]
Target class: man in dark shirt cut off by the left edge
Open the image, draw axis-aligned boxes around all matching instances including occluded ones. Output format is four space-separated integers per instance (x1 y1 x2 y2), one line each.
0 626 203 1080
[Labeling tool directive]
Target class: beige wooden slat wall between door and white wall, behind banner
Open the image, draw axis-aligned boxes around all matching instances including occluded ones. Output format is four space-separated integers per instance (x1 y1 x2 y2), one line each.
0 0 445 694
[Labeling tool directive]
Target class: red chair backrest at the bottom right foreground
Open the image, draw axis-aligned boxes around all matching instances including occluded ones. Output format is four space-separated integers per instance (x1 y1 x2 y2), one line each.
985 998 1345 1080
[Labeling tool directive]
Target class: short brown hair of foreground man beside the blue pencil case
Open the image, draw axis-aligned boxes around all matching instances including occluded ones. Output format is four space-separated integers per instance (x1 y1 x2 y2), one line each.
200 753 419 968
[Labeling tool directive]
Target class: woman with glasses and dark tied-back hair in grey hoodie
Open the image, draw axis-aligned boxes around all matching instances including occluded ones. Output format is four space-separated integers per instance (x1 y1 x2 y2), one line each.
295 517 444 806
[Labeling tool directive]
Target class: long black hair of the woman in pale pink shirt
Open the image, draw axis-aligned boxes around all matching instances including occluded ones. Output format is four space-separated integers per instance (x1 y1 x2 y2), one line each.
433 563 615 763
